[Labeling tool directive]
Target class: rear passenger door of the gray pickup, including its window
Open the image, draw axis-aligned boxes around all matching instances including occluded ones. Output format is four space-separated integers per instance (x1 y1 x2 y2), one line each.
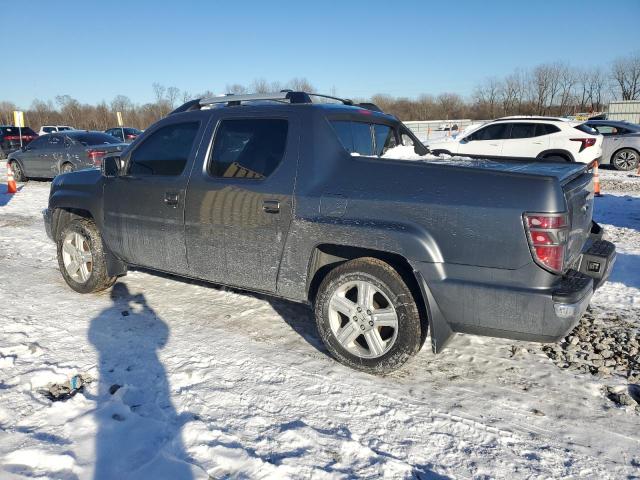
185 111 300 292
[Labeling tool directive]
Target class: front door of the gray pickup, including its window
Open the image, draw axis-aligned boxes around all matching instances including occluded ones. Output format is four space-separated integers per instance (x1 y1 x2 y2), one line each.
103 115 206 273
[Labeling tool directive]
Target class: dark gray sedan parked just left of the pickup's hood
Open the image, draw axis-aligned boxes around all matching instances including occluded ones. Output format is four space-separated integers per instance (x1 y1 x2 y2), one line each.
7 130 126 182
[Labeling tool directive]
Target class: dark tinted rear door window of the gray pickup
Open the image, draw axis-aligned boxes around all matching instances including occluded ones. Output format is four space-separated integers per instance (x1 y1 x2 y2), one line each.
209 118 289 179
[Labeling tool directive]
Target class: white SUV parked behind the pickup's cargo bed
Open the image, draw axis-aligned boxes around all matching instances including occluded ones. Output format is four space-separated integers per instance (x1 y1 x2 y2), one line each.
429 117 603 163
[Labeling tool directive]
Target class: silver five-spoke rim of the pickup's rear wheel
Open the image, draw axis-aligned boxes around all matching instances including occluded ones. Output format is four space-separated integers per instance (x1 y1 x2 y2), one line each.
329 280 398 358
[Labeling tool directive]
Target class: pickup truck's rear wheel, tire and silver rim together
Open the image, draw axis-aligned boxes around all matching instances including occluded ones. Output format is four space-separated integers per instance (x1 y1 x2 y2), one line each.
315 258 423 374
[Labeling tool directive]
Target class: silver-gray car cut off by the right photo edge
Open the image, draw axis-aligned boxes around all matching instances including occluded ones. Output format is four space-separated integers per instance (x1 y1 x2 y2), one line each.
586 120 640 170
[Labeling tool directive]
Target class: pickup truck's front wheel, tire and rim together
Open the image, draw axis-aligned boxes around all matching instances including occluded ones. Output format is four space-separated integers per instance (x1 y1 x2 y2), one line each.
57 218 116 293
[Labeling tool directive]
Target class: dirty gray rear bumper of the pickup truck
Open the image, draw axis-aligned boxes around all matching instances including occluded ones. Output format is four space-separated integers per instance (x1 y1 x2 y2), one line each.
414 227 616 352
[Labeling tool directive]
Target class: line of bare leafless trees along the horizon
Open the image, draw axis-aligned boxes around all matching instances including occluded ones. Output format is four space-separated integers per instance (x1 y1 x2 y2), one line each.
0 52 640 130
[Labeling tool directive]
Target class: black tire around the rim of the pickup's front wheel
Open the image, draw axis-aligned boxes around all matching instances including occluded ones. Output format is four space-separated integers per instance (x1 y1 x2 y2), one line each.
56 218 117 293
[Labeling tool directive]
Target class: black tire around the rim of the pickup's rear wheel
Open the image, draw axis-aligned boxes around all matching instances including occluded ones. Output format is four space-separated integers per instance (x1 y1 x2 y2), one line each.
315 257 426 374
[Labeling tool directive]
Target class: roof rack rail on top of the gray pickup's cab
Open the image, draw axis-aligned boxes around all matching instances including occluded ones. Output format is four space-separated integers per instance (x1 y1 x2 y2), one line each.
169 90 382 115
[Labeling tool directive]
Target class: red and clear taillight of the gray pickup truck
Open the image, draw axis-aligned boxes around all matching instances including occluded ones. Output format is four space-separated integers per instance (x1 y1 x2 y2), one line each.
524 213 569 273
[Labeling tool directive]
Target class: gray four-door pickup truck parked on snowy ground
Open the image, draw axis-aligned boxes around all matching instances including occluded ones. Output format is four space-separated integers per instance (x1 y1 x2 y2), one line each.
44 92 615 373
